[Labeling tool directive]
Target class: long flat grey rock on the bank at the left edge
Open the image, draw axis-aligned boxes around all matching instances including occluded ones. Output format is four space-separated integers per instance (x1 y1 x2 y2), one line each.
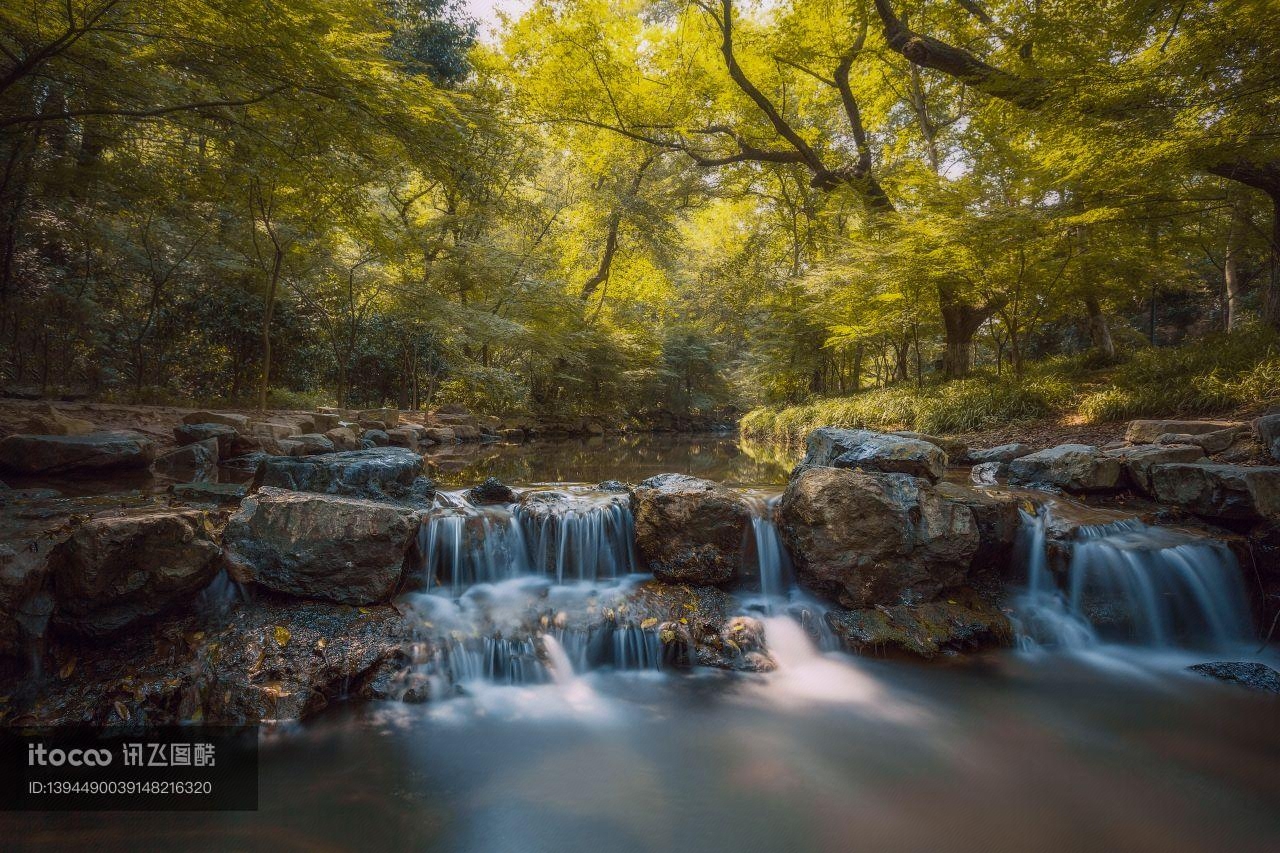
0 432 156 474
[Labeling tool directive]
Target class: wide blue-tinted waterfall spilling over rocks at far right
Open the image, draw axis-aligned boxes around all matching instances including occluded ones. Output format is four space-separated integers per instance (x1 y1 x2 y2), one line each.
1015 511 1251 648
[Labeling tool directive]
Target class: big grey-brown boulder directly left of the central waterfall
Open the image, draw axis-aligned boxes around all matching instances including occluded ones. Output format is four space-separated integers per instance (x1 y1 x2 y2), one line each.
223 487 421 605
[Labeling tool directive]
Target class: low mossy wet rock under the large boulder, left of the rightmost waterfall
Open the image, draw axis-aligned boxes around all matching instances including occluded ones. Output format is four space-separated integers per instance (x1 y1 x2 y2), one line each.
826 590 1014 658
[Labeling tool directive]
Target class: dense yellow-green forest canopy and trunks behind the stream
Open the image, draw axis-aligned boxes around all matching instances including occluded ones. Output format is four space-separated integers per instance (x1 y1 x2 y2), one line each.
0 0 1280 428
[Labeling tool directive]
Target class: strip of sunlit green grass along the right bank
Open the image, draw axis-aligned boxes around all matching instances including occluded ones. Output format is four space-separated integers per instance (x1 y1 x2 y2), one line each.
741 328 1280 444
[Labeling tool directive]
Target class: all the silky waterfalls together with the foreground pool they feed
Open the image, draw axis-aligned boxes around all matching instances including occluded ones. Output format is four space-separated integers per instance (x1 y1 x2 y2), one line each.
0 439 1280 853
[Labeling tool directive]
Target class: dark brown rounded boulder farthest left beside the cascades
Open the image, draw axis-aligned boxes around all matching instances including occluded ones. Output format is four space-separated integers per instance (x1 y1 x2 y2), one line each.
49 510 220 638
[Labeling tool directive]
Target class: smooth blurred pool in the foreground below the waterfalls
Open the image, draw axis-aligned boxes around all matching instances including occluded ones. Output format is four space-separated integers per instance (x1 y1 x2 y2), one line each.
10 649 1280 853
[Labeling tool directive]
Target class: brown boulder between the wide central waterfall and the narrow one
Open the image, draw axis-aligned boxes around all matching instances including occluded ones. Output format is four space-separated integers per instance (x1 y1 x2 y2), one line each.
631 474 751 585
